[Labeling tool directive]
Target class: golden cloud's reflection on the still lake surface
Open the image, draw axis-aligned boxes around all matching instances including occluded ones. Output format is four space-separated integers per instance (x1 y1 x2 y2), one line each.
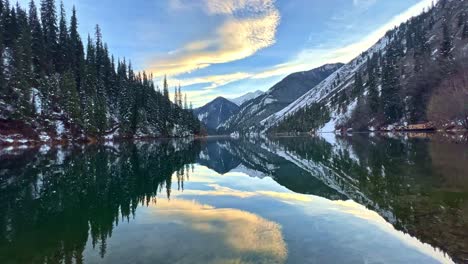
151 199 288 263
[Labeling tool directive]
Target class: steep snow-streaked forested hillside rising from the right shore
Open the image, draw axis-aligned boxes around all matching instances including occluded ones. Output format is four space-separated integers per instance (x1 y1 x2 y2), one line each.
262 0 468 132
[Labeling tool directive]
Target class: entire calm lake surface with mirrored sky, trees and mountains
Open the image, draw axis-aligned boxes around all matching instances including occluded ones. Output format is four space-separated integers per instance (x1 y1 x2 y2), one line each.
0 135 468 263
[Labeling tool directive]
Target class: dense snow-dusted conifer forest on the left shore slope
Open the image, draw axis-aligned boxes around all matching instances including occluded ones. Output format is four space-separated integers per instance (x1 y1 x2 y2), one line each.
0 0 200 143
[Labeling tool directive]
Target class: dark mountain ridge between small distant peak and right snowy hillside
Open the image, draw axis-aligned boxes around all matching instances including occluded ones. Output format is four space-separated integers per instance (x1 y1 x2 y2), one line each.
218 64 342 133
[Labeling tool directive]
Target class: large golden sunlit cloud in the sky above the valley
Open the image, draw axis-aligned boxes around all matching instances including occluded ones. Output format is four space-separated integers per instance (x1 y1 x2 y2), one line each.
149 0 280 76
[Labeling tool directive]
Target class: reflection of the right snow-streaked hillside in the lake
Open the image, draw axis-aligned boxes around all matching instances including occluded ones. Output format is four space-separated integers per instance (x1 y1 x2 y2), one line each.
199 134 468 262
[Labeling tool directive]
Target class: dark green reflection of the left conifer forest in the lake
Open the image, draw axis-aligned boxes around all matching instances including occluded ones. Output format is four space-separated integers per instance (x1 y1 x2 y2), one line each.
0 142 200 263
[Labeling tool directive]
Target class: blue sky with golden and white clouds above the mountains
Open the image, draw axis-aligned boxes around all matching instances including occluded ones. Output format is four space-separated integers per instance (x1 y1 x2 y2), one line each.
20 0 432 106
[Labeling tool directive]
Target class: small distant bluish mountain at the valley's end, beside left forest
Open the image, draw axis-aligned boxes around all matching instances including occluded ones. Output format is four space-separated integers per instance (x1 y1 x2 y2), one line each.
193 97 239 133
